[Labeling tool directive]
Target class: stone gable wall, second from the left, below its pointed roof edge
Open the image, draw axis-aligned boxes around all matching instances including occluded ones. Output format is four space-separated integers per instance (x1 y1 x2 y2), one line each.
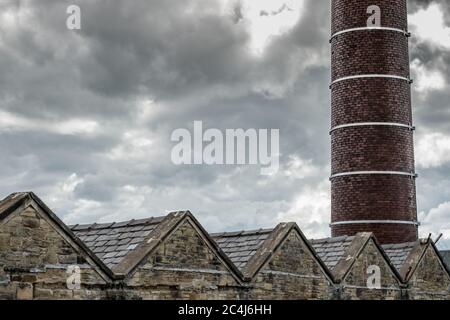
124 219 240 299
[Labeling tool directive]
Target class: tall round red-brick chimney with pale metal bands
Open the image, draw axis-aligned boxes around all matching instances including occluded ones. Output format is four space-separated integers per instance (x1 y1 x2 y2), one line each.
330 0 418 243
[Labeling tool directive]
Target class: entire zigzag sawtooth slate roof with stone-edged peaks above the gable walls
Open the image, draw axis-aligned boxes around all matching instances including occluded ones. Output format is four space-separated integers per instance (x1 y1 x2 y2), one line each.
0 192 450 281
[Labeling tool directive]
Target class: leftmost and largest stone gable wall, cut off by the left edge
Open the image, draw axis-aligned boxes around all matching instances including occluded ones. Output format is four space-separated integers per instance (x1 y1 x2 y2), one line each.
0 206 109 300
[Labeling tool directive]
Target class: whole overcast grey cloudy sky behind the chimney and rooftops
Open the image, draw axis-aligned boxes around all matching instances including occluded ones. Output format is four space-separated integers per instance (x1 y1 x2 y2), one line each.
0 0 450 249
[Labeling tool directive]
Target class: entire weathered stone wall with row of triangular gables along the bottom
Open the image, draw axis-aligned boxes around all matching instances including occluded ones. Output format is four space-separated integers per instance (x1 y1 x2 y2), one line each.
0 203 450 299
